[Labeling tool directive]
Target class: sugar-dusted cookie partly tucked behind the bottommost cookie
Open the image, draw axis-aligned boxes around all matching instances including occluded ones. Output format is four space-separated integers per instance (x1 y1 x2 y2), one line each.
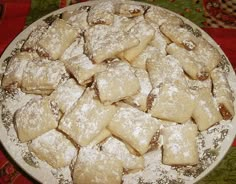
102 137 144 170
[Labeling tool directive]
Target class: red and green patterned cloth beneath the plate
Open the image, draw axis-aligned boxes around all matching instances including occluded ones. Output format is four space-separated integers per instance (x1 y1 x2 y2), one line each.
0 0 236 184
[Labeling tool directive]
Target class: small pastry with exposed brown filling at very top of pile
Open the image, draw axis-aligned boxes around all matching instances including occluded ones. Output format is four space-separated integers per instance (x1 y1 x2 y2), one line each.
118 3 144 18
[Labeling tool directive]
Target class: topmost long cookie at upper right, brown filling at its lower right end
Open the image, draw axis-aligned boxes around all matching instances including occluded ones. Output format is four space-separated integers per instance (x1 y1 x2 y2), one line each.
160 22 199 50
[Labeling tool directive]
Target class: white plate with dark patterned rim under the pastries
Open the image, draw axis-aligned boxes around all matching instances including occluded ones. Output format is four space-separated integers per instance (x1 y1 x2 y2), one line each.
0 1 236 183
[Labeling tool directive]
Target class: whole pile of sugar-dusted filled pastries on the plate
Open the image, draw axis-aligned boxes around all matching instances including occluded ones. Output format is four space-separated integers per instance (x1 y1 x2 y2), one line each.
2 1 234 184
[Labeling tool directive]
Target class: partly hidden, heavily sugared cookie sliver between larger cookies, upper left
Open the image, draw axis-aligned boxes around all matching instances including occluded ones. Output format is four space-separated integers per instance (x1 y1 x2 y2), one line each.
60 37 84 61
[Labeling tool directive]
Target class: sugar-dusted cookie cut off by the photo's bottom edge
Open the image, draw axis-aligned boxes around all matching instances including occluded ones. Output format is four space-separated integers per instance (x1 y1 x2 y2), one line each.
72 147 123 184
